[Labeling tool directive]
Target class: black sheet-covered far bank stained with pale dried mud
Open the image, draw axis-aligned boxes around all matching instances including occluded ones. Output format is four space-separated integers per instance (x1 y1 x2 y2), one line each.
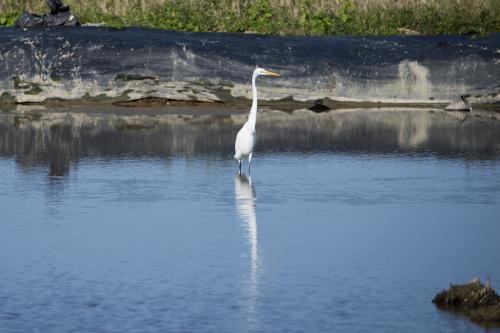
0 27 500 104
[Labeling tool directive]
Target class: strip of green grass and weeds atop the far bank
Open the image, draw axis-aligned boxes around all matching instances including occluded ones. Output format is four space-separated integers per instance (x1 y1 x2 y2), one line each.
0 0 500 35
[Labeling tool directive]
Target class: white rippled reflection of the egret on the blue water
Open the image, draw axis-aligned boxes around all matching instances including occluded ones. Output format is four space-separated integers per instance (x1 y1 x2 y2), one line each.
234 173 259 329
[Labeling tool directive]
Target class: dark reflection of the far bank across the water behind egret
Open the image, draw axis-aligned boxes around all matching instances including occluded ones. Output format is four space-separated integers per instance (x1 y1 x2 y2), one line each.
0 109 500 177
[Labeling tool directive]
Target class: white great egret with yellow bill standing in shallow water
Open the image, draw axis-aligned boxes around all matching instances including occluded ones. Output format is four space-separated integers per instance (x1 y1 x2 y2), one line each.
234 67 279 173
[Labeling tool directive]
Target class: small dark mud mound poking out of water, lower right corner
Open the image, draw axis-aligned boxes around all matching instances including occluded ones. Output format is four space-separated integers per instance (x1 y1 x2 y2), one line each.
432 279 500 327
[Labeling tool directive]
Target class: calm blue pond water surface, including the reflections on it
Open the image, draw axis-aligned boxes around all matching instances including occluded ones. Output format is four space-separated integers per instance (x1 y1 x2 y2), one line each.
0 110 500 333
